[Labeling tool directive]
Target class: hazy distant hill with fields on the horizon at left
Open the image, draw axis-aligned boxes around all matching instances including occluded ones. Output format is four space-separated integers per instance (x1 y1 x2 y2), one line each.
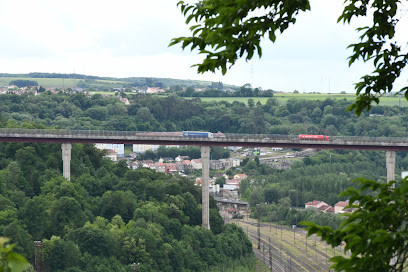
0 73 236 89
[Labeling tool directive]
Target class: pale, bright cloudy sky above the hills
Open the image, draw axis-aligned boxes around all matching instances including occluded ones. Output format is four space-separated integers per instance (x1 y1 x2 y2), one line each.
0 0 408 93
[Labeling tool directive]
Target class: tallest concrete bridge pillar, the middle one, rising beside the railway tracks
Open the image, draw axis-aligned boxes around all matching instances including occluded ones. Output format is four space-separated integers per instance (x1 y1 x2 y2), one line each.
201 146 210 229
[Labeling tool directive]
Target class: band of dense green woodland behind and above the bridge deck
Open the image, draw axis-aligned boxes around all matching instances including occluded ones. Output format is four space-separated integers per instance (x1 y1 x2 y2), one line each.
0 93 408 137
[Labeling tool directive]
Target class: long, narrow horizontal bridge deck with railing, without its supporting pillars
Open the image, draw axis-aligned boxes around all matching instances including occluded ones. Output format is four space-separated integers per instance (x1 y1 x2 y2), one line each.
0 128 408 151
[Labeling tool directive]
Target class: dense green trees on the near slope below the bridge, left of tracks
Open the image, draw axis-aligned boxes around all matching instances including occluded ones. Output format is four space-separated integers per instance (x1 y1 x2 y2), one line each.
0 140 253 271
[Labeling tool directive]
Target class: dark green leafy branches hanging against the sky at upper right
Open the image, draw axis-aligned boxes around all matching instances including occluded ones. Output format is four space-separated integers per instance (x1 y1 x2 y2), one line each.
170 0 408 115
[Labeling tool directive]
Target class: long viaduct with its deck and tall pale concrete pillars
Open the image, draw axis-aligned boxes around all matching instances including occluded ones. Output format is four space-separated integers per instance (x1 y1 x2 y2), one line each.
0 128 408 229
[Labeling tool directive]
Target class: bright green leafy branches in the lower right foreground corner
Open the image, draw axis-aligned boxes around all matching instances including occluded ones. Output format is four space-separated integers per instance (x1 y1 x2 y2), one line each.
303 178 408 272
